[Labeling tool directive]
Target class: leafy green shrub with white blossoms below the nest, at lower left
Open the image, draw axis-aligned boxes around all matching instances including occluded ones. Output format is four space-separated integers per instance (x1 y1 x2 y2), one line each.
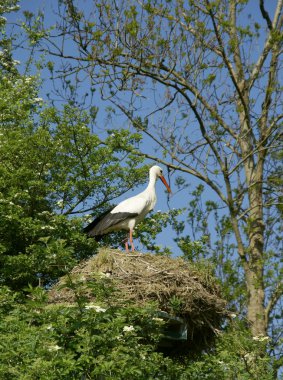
0 284 183 380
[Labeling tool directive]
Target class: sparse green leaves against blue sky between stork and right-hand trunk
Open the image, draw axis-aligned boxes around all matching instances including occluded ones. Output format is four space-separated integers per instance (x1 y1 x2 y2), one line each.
176 185 247 310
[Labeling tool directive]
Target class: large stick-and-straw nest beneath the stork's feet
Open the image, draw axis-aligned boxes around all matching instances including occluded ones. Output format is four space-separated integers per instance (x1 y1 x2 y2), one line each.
49 248 228 351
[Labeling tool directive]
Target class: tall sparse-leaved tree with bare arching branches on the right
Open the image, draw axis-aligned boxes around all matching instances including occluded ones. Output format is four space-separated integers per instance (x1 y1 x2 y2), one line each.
36 0 283 364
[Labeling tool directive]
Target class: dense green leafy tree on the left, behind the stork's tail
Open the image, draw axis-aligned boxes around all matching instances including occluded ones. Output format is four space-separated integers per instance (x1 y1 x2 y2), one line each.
0 1 154 290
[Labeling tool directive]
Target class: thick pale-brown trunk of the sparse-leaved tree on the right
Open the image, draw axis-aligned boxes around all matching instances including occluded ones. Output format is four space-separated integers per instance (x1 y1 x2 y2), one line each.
238 86 267 336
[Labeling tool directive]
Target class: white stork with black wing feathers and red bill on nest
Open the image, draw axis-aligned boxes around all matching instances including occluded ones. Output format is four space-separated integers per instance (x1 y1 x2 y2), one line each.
84 165 171 252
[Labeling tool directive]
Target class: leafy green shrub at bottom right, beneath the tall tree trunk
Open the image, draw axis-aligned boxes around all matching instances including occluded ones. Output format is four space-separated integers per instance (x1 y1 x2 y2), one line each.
181 322 275 380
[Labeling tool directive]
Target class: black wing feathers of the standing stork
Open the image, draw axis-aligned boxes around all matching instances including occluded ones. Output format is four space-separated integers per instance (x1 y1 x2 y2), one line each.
84 208 138 236
